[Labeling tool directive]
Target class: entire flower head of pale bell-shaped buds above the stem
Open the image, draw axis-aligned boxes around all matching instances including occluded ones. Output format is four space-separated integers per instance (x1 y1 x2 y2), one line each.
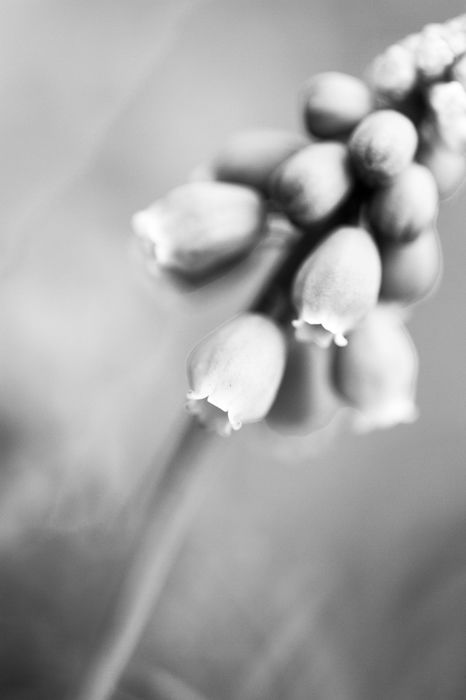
133 15 466 434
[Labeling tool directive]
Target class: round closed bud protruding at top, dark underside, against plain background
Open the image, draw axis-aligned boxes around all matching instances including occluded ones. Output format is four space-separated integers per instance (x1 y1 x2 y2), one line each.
303 72 373 138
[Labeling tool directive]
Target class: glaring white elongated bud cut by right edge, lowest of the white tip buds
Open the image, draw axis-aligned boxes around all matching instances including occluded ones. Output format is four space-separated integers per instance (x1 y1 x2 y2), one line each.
426 80 466 151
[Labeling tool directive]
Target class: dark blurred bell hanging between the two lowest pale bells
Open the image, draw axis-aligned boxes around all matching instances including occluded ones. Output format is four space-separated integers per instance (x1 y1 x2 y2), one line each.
266 339 338 435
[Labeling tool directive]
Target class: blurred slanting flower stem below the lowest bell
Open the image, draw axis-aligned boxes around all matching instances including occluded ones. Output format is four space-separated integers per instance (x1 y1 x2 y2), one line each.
71 419 210 700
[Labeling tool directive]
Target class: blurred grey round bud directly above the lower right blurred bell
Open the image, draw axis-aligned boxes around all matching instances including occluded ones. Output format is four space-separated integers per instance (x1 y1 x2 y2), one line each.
380 228 442 304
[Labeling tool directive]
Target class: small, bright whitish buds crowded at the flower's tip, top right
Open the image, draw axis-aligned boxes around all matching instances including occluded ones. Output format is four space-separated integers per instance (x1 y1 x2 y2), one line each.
368 15 466 196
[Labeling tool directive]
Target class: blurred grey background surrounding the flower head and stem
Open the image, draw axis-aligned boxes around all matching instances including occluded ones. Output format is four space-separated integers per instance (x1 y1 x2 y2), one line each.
0 0 466 700
